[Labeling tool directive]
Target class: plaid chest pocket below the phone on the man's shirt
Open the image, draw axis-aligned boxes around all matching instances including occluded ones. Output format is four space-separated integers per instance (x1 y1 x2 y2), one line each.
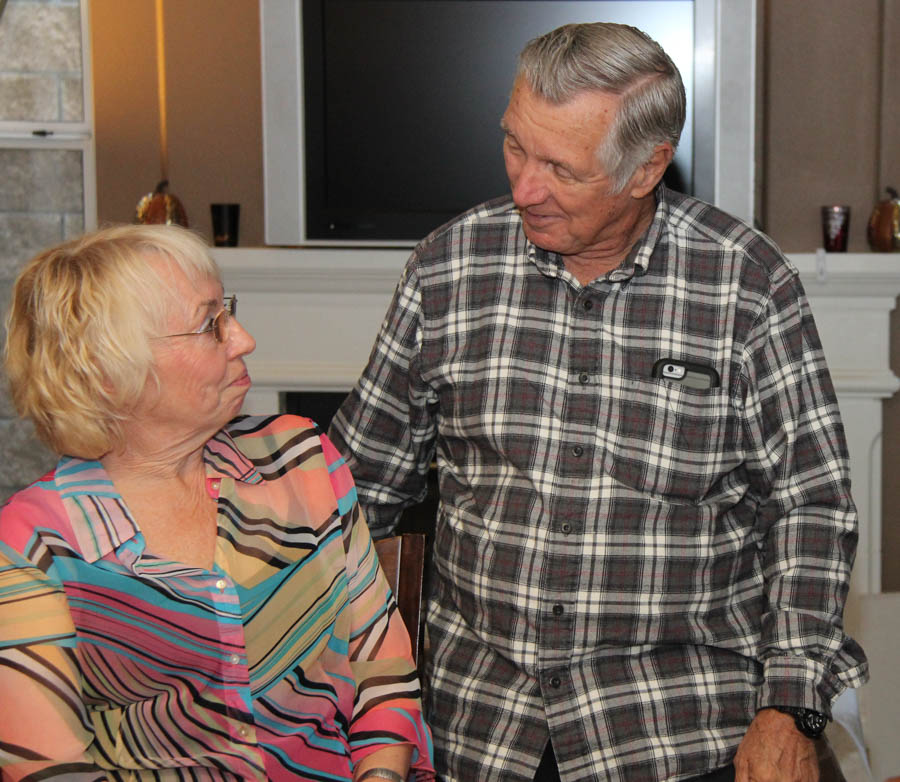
598 379 742 503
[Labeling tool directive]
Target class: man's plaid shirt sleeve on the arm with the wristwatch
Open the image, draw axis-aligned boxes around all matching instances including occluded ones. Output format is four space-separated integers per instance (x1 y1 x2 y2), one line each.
742 275 867 713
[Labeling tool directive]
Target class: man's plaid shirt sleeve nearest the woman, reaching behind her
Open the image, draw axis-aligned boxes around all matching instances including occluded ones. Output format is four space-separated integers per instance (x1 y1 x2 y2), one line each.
329 254 437 538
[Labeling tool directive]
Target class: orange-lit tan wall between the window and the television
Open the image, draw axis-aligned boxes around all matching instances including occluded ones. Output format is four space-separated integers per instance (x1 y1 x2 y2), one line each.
90 0 263 246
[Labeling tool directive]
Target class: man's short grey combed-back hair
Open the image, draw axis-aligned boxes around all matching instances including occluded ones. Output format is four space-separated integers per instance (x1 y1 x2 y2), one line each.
516 22 686 192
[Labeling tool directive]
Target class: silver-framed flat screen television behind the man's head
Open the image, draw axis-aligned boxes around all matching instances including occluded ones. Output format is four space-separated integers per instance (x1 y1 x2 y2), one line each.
261 0 755 246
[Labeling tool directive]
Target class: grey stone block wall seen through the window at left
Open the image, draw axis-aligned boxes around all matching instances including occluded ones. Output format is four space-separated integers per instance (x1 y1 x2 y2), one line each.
0 0 84 502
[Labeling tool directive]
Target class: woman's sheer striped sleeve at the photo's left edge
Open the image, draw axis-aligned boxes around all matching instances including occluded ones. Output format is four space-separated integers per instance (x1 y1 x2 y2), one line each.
0 540 107 782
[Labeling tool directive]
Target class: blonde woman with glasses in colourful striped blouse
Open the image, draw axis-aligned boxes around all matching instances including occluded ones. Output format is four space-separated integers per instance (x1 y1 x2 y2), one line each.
0 226 434 782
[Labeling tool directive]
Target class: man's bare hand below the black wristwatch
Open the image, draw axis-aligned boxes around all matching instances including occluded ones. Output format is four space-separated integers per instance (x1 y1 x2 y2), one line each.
734 709 819 782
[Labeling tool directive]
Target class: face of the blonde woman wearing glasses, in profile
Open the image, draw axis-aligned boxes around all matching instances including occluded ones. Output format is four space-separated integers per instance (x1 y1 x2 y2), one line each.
136 259 256 445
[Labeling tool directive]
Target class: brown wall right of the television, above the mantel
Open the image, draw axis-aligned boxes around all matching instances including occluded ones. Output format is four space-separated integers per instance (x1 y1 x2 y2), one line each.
761 0 888 252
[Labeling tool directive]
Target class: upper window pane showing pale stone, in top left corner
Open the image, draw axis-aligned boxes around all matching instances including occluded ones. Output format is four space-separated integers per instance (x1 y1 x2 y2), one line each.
0 0 84 122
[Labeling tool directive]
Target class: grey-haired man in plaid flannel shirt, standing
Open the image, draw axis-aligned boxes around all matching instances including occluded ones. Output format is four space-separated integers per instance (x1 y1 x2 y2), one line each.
332 24 866 782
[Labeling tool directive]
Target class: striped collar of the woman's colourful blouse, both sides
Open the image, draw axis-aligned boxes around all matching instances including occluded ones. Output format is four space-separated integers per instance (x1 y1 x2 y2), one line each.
54 430 263 565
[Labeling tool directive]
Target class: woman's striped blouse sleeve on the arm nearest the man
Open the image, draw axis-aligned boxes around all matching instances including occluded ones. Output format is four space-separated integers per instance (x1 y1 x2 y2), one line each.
322 437 434 780
